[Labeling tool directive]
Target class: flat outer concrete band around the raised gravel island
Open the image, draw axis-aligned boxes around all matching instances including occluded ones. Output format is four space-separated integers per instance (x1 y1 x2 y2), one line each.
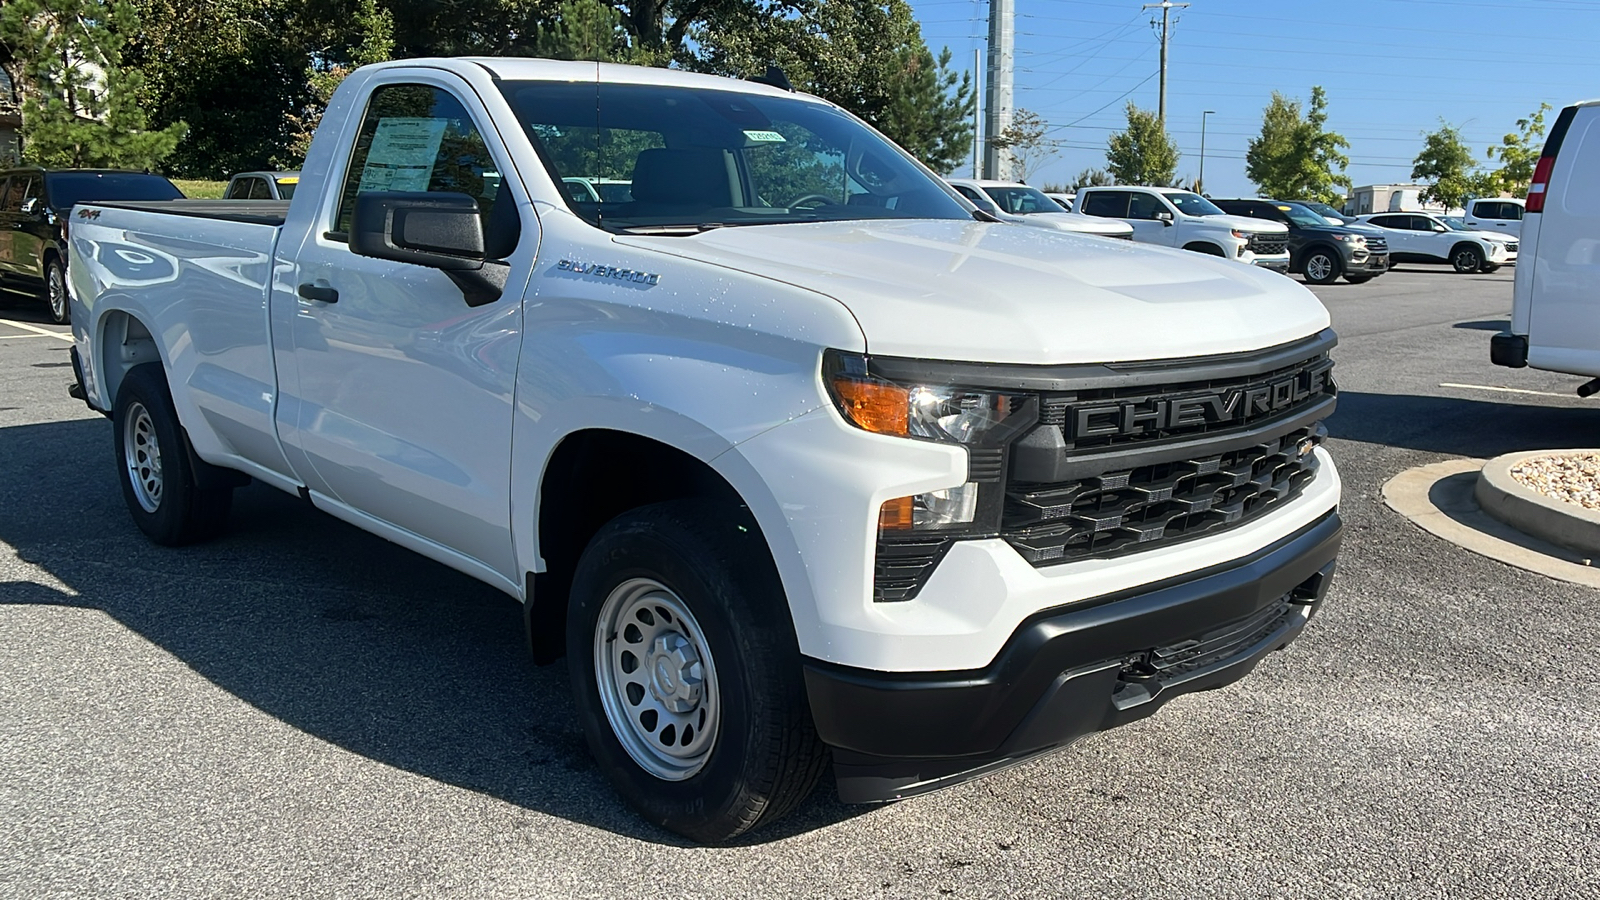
1384 460 1600 588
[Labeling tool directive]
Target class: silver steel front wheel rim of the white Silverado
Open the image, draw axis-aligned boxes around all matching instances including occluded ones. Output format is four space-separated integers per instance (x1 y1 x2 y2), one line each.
594 578 722 781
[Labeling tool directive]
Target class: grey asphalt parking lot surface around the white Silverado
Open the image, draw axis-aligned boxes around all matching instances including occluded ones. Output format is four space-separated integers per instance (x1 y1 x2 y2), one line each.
0 267 1600 898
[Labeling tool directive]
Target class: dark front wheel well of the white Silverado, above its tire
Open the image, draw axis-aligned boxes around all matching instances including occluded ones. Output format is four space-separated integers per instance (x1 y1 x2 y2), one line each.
525 429 755 665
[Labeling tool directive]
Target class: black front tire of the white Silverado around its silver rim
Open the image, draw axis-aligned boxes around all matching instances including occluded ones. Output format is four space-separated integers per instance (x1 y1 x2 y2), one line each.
566 500 827 842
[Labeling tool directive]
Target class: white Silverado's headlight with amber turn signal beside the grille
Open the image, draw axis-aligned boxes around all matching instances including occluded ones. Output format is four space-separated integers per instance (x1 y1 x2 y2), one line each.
822 351 1038 538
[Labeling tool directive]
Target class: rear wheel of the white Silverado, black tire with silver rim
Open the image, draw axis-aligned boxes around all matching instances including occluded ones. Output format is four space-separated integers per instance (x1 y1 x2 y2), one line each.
112 364 234 546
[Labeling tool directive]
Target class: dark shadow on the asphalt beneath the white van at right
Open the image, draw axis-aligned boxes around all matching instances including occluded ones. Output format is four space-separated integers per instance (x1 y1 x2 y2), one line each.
1328 391 1600 458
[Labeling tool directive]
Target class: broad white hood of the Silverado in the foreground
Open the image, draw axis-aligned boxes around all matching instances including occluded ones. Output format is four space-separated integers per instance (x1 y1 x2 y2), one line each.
614 219 1328 364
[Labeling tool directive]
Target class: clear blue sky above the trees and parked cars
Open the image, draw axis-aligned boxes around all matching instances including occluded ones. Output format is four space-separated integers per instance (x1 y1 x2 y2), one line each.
909 0 1600 197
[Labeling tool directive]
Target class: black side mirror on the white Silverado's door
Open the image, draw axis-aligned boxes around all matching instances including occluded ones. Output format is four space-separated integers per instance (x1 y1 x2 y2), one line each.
350 191 510 306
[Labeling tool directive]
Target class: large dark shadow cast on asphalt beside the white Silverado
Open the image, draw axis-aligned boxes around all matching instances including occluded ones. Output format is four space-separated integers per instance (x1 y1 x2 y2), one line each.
0 418 869 846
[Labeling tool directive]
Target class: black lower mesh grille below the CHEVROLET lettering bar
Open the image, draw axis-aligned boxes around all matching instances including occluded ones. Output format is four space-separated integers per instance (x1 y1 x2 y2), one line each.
1002 426 1320 565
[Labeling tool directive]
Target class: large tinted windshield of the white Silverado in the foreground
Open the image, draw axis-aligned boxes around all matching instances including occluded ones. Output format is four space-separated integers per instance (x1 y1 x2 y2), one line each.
501 82 971 231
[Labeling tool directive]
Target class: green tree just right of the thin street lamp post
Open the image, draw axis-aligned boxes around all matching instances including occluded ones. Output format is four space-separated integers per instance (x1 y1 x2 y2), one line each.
1245 85 1350 203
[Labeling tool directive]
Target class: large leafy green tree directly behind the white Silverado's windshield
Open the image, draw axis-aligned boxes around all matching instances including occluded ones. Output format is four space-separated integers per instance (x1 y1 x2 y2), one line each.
691 0 978 171
